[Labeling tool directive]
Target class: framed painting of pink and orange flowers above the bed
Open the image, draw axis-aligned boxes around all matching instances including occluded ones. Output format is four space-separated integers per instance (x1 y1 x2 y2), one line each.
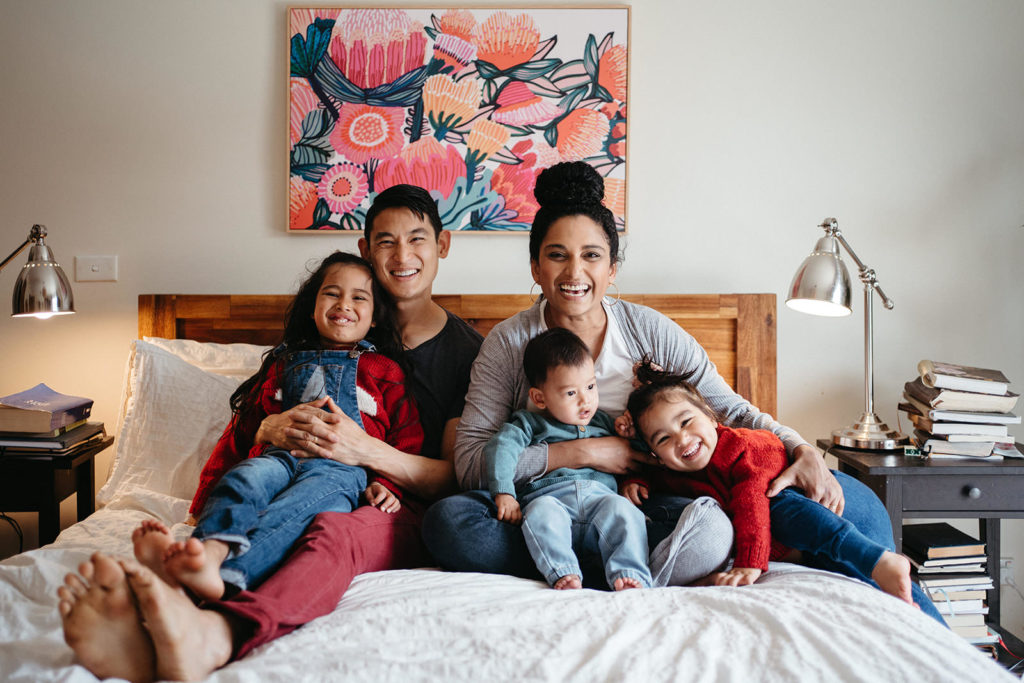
288 6 630 233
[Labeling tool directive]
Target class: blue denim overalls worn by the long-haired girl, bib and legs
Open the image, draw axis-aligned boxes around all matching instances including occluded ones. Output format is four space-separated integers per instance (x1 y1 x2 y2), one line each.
193 341 374 590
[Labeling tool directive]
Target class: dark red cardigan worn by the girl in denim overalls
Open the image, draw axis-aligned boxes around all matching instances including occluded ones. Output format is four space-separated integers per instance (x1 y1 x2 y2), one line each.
188 352 423 516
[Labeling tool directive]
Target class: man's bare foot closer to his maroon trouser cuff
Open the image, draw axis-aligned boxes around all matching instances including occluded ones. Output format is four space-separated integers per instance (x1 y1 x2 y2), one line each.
121 560 232 681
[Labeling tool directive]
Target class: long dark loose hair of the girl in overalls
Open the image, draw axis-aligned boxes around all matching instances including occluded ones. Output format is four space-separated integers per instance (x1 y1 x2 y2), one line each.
230 251 412 444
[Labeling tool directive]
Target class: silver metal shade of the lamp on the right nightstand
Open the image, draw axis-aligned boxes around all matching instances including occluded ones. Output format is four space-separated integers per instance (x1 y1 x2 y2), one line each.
785 234 853 317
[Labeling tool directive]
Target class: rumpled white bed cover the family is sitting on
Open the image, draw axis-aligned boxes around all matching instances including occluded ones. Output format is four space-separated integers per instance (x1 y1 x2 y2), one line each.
0 490 1018 683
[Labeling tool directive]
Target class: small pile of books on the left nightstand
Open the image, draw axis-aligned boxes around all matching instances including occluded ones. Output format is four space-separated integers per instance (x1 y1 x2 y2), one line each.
0 384 106 457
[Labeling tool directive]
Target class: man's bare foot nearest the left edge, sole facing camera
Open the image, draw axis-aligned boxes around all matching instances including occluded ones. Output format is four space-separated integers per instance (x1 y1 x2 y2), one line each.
57 553 156 682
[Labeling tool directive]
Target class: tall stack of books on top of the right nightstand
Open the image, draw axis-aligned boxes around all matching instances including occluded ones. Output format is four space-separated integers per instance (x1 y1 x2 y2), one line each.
899 360 1021 460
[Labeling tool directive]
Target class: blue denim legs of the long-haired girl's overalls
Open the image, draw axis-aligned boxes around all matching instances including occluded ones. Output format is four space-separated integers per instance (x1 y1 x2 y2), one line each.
193 449 367 590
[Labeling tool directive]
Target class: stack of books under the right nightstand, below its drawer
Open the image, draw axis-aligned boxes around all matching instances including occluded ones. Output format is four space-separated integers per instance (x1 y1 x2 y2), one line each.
903 522 998 655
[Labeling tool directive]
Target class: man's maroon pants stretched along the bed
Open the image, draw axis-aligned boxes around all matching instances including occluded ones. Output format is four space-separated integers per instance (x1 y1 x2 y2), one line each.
206 498 433 659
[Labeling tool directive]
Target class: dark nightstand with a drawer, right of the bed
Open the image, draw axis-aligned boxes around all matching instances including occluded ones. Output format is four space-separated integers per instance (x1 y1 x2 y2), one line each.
817 439 1024 654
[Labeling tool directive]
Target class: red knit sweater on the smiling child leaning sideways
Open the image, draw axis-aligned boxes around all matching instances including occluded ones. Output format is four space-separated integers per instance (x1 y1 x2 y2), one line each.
634 425 790 570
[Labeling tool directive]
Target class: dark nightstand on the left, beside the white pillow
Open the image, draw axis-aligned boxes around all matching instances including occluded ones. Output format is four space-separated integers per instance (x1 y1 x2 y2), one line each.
0 436 114 546
